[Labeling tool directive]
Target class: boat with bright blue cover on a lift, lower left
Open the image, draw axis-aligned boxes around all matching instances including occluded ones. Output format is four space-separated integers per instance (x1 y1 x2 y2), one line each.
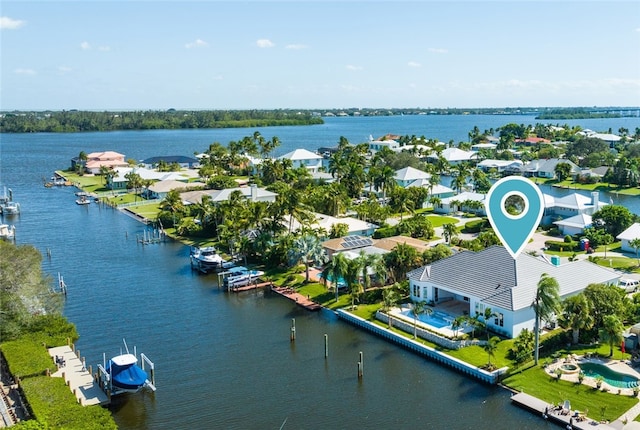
98 339 156 395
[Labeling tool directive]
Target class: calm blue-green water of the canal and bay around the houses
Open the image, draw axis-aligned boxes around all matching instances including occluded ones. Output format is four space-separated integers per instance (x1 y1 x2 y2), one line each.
0 116 640 429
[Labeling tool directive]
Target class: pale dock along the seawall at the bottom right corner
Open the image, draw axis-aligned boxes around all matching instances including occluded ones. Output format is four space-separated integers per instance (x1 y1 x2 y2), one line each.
511 393 632 430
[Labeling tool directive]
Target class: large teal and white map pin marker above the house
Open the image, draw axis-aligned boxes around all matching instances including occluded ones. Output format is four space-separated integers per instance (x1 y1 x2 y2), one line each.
485 176 544 260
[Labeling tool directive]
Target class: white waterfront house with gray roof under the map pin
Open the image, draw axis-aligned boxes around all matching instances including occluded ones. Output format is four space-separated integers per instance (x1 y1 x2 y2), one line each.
407 245 620 338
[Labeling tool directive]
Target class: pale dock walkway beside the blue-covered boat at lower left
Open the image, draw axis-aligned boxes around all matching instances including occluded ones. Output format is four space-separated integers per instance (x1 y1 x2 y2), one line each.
49 345 109 406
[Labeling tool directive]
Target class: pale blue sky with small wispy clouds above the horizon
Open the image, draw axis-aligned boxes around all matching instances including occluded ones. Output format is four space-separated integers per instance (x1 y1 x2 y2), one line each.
0 0 640 110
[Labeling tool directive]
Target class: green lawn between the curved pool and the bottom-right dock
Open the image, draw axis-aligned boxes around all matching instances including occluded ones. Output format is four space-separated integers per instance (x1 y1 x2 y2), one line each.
503 366 638 421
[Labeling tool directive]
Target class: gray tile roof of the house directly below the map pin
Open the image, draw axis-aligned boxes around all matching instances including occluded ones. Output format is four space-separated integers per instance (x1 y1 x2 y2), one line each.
407 245 620 311
